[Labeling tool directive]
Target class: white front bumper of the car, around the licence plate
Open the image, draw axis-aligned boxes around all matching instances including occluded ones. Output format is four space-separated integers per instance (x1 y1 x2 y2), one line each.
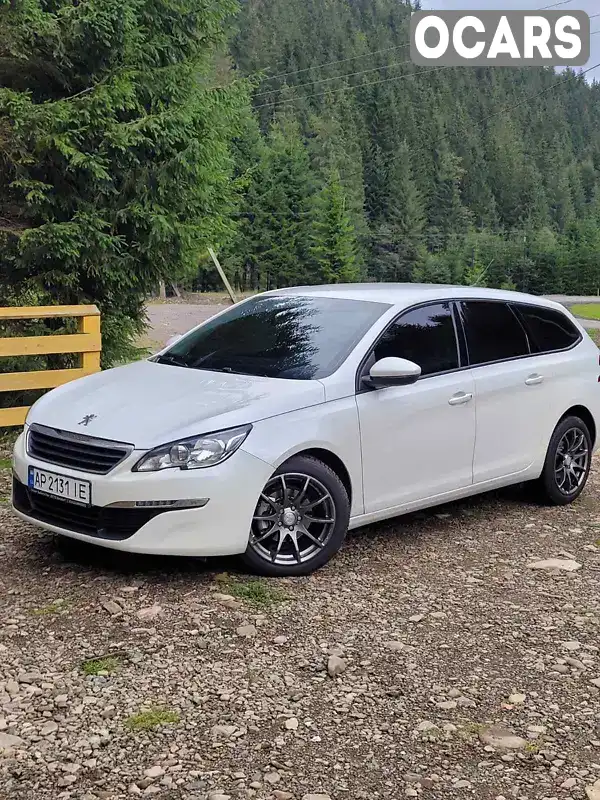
13 435 273 556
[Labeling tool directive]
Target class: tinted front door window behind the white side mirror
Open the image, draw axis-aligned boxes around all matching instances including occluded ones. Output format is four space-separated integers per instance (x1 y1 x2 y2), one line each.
375 303 458 375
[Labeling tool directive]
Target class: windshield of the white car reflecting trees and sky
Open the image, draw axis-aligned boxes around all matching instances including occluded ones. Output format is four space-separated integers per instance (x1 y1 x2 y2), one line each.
153 295 389 380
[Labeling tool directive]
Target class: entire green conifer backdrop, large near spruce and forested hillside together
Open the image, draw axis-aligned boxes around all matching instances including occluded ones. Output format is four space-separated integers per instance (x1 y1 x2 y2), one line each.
0 0 600 376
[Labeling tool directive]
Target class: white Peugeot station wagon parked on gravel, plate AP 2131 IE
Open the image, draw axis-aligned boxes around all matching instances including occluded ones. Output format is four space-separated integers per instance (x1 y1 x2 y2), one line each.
13 284 600 575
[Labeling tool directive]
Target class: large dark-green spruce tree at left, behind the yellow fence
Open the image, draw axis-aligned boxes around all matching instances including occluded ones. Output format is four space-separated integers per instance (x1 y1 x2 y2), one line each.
0 0 245 363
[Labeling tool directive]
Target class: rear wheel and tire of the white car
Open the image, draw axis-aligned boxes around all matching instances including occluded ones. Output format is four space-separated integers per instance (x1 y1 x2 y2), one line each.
536 416 593 506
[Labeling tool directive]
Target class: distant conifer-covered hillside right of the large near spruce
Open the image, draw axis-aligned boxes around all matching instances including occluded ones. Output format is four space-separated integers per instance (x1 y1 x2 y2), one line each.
225 0 600 293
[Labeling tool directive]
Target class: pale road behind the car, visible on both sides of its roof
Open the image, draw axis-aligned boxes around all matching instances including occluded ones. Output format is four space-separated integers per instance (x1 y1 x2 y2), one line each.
148 295 600 349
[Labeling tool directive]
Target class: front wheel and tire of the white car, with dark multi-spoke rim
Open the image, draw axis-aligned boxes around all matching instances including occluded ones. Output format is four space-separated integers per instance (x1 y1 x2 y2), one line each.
242 455 350 577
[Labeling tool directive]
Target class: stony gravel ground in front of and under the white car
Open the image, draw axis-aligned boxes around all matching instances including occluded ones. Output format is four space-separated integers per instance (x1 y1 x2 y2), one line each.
0 440 600 800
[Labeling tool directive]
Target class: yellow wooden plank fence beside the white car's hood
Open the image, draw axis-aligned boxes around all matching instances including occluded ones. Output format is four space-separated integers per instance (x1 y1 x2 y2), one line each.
0 306 102 428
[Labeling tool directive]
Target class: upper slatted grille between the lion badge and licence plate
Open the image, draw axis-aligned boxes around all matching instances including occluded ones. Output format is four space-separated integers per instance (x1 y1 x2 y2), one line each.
27 424 133 475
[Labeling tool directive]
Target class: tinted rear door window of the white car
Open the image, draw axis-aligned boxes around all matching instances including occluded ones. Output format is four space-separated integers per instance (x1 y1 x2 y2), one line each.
461 300 529 364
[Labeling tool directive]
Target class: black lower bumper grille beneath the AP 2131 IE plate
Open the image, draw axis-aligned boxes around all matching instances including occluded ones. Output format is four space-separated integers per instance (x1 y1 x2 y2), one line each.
13 477 168 541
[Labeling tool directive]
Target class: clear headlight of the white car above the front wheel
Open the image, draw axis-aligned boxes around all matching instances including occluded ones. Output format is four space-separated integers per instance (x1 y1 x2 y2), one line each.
133 425 252 472
